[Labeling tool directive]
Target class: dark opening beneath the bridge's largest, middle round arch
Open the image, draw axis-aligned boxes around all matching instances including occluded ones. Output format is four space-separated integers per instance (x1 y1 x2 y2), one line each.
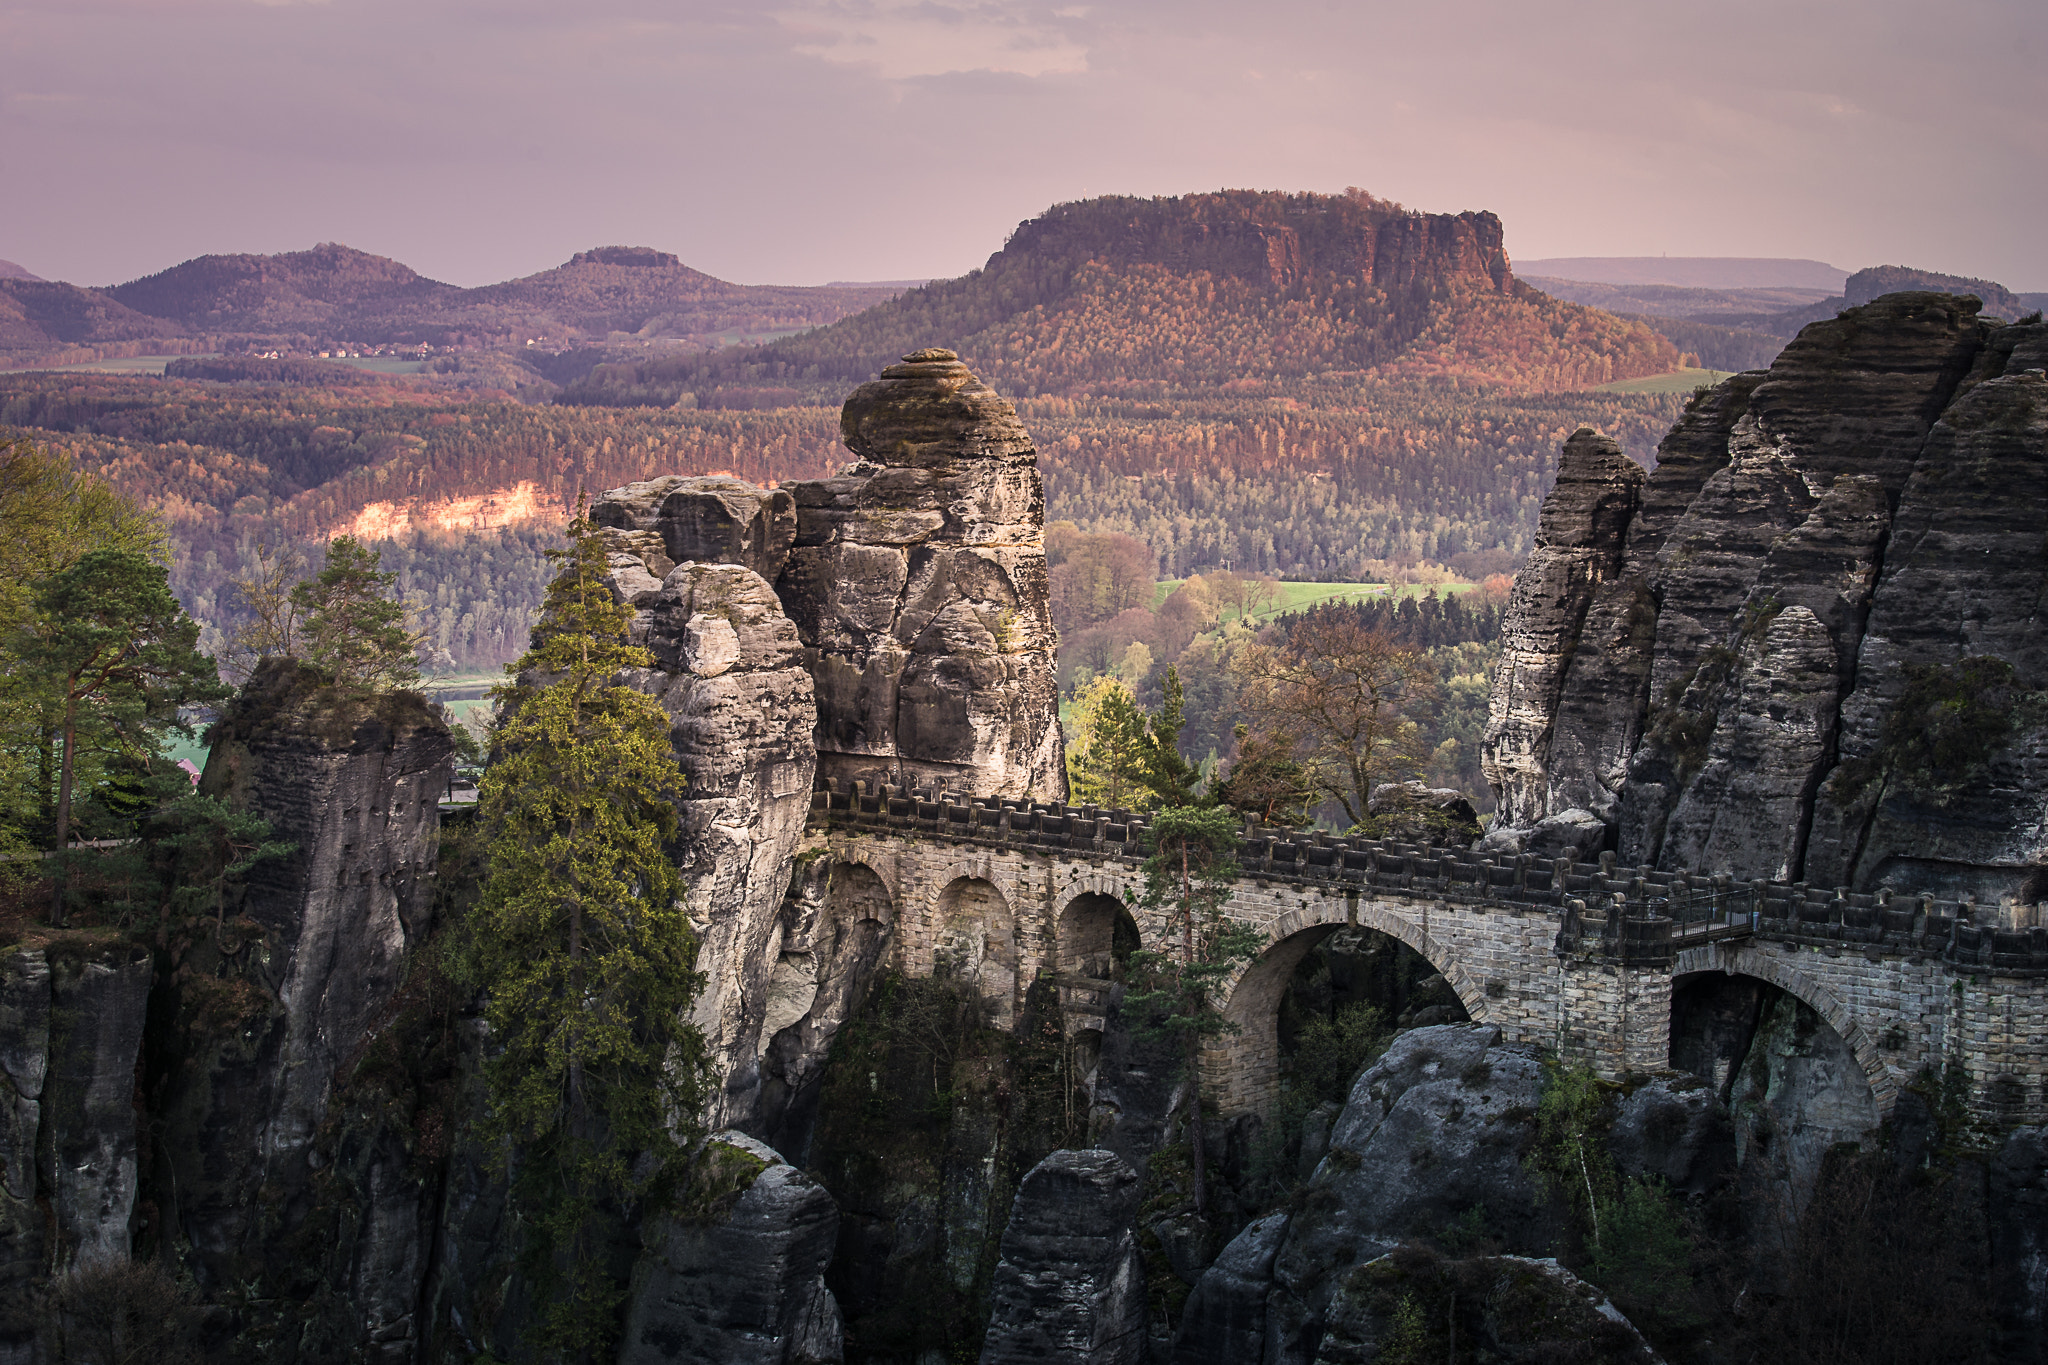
1225 925 1470 1197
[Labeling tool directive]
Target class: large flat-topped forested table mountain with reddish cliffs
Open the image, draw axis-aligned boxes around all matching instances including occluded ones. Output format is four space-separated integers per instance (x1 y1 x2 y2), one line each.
561 190 1677 407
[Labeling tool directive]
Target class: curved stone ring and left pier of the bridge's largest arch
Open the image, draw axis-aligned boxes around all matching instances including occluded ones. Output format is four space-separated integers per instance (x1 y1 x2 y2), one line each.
1202 898 1487 1115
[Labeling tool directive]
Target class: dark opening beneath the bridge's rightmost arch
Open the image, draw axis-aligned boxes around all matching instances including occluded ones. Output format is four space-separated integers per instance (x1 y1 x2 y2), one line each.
1671 972 1880 1246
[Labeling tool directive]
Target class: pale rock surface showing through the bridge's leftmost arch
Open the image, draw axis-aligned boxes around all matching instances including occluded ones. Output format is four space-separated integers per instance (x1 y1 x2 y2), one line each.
756 862 895 1164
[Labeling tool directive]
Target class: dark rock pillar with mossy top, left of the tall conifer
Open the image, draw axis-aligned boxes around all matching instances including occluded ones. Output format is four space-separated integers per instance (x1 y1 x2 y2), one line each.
152 661 455 1287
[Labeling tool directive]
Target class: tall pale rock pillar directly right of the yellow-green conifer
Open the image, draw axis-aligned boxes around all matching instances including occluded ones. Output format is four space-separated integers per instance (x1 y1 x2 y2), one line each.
590 507 817 1126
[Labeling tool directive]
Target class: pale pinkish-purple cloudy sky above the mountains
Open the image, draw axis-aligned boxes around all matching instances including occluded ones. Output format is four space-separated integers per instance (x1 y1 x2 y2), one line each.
0 0 2048 291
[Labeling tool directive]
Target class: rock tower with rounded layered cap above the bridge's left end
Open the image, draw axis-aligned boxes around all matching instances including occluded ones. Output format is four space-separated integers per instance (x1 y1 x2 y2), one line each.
776 350 1065 800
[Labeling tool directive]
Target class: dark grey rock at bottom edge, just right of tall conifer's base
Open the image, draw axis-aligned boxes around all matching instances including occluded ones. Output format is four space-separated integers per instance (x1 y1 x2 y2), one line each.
618 1132 844 1365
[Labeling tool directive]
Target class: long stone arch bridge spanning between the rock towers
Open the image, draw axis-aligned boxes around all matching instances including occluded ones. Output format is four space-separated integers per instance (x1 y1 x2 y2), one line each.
803 784 2048 1124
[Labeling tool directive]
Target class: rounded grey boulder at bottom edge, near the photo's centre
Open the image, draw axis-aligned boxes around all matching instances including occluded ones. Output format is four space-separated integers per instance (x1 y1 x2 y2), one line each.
981 1150 1145 1365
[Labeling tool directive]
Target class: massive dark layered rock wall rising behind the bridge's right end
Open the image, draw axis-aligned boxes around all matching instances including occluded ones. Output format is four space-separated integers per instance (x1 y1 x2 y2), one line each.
1485 295 2048 900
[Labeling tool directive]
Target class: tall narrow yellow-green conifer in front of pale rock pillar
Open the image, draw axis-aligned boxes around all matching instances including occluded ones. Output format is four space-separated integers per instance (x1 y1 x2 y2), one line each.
459 516 707 1357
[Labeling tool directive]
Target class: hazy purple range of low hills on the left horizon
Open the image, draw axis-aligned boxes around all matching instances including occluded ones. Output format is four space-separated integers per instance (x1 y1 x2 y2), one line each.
0 241 901 368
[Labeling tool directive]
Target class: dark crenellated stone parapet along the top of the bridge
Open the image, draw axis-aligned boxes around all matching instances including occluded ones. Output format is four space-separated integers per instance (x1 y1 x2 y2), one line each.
811 780 2048 976
